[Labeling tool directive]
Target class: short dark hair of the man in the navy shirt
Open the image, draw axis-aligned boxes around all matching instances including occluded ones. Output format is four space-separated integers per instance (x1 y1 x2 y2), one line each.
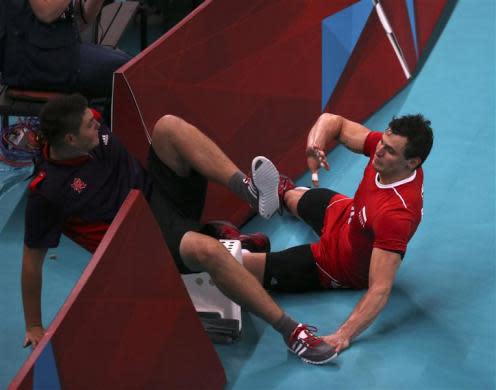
40 94 88 146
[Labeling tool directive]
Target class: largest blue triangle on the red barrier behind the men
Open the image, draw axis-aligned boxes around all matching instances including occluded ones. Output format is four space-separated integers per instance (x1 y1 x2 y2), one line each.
321 0 373 110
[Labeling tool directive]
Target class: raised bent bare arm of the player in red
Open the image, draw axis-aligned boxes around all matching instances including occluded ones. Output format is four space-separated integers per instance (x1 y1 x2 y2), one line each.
306 113 370 186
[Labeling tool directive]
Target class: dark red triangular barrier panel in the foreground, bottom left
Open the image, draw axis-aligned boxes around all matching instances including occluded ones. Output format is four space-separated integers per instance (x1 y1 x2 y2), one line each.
12 191 226 389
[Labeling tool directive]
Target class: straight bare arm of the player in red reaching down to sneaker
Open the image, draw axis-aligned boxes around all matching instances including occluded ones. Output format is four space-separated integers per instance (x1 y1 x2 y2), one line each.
323 248 401 352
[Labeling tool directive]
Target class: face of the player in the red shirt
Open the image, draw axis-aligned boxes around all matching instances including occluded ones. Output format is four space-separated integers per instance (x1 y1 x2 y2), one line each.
372 129 411 177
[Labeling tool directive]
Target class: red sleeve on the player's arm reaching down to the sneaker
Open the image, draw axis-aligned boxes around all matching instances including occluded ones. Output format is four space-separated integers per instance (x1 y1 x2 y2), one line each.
372 210 418 254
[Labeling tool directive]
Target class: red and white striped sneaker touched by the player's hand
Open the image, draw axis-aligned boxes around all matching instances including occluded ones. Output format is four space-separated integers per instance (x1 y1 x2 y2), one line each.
286 324 338 364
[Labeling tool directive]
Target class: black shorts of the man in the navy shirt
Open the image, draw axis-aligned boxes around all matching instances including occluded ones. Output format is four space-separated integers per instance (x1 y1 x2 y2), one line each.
148 146 208 273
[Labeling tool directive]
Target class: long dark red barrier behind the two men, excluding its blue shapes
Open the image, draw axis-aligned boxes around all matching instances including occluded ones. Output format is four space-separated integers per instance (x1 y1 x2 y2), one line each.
113 0 454 224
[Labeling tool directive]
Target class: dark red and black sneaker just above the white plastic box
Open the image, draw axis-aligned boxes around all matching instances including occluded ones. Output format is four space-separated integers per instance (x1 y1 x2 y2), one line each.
207 221 270 253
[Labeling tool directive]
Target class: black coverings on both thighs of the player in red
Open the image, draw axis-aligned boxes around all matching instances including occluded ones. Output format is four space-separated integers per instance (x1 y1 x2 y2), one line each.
263 188 338 292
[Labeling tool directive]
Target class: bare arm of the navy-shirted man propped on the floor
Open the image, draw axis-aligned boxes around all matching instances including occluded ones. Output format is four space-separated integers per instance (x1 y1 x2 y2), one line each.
21 245 47 347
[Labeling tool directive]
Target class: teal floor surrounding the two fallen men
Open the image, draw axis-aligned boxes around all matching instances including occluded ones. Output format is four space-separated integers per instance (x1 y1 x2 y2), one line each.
0 0 496 390
